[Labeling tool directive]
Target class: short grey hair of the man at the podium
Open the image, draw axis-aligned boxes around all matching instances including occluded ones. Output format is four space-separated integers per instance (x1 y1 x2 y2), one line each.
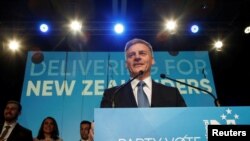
124 38 154 58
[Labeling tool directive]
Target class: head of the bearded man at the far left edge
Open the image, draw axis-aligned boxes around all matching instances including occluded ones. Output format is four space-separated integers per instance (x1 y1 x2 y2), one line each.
4 103 20 122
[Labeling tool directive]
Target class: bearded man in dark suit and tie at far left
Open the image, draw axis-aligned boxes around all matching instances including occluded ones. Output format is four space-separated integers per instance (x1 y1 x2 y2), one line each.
0 101 33 141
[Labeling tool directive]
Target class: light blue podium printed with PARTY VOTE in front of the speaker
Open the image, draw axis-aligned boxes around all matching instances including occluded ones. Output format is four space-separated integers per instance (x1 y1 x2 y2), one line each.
94 106 250 141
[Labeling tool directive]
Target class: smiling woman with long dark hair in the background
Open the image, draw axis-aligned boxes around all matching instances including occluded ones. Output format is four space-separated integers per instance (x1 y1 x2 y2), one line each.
34 117 62 141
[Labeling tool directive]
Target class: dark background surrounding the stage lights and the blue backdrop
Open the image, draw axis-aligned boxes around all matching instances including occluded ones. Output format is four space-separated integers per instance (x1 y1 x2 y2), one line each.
0 0 250 119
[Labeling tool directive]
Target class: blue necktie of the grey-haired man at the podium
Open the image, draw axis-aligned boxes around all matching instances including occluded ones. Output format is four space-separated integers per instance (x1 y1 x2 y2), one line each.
137 81 149 107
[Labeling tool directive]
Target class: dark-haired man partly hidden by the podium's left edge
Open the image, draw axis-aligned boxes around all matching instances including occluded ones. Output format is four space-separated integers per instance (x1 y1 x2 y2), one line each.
80 120 92 141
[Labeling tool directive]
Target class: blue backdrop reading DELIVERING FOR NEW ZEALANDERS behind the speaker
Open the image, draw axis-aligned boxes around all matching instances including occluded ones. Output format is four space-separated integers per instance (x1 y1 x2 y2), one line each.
20 51 216 141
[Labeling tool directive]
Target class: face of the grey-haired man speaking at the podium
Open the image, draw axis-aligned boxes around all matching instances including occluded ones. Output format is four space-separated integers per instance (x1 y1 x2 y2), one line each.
126 43 155 77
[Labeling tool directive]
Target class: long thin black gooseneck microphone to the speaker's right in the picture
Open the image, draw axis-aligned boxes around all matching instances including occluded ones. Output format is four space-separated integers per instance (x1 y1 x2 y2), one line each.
160 74 220 107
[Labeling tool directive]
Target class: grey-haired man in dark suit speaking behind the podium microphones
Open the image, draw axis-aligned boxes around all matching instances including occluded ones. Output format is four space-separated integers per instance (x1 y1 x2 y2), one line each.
101 39 186 108
